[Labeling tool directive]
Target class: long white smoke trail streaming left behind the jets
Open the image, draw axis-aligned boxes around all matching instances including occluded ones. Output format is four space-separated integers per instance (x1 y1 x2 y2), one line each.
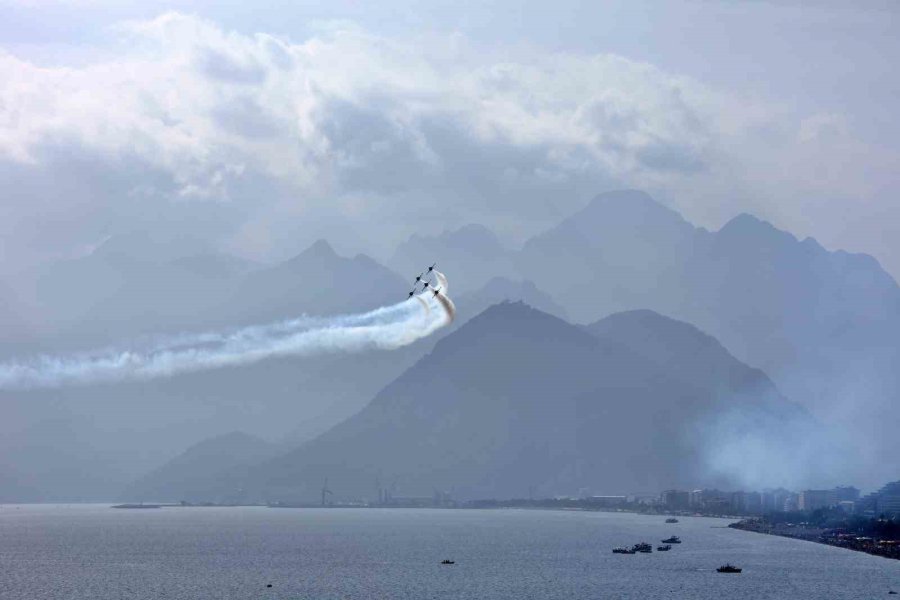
0 297 455 389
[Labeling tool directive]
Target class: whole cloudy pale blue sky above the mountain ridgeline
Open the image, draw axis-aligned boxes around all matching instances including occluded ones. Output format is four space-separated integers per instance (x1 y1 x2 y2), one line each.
0 0 900 281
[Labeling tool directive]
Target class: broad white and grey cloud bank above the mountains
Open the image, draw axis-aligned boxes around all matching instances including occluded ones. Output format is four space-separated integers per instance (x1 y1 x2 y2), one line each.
0 13 896 276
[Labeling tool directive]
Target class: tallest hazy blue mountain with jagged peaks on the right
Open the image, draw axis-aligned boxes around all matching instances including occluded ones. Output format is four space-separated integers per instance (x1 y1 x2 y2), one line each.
516 191 900 481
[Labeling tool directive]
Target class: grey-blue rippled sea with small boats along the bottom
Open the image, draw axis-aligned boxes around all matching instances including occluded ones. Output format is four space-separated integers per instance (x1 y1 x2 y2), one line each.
0 505 900 600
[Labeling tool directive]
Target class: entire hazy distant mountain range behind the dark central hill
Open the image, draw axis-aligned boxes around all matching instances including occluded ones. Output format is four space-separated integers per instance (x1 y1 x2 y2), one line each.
0 191 900 500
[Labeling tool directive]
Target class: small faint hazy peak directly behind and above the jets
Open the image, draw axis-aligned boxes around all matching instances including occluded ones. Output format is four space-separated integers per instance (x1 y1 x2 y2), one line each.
388 225 514 294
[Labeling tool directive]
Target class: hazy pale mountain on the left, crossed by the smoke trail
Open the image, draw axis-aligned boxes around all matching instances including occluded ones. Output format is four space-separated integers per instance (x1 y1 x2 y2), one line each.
0 236 430 501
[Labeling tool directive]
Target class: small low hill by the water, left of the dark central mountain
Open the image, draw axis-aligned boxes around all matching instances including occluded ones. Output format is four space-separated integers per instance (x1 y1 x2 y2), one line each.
122 431 276 502
